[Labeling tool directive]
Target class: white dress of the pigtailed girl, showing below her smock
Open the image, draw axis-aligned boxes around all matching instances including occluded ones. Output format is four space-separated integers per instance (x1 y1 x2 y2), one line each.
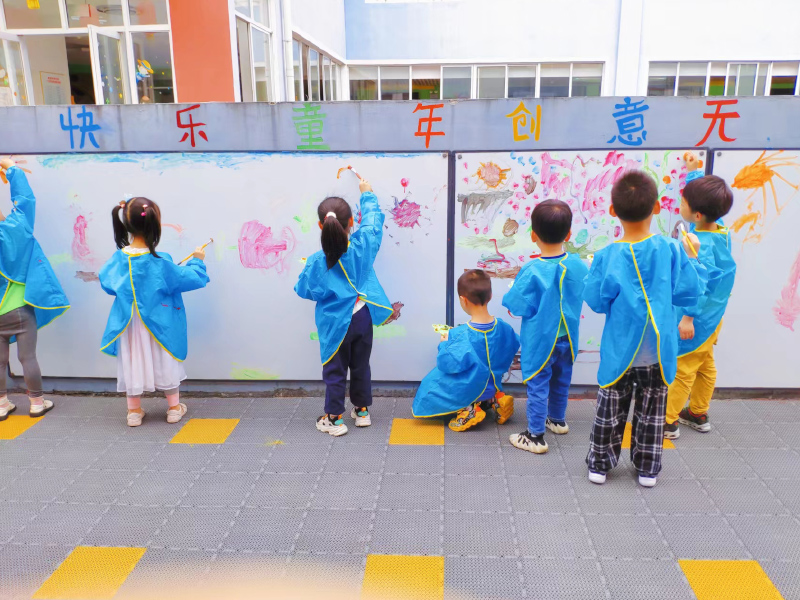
117 248 186 397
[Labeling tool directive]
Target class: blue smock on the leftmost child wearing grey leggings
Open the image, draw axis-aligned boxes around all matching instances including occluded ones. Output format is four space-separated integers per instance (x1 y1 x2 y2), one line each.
0 167 69 343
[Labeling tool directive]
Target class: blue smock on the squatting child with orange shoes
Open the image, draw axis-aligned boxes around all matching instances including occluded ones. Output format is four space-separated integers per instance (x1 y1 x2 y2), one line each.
411 318 519 417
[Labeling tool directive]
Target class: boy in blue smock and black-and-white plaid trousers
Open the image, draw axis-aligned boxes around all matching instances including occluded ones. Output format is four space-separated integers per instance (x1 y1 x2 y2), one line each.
584 171 705 487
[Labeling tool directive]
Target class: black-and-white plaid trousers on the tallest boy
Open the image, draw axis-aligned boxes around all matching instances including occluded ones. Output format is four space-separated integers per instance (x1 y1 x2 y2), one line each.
586 363 668 477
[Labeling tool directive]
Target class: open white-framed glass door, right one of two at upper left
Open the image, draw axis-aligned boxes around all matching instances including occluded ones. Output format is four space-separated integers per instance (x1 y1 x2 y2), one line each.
89 25 130 104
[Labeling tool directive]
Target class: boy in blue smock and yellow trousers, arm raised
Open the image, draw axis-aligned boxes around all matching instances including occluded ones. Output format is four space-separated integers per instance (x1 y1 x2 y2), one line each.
664 153 736 440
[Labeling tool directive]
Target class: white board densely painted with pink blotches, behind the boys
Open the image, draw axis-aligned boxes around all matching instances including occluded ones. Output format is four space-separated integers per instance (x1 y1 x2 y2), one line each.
454 150 704 385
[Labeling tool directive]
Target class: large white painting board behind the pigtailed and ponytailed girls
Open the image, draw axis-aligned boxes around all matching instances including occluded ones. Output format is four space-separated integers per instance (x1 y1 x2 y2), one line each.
3 153 447 381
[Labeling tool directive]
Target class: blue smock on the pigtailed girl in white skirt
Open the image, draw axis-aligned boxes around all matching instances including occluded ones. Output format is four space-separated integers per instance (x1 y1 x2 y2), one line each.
100 250 209 362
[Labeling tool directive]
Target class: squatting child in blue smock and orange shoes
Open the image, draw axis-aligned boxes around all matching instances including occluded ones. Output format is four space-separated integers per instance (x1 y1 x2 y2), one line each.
412 269 519 431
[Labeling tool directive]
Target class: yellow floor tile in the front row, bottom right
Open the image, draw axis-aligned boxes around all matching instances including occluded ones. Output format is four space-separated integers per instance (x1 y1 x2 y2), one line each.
678 560 783 600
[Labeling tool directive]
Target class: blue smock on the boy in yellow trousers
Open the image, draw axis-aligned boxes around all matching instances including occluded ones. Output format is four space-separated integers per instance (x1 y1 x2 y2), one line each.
678 223 736 356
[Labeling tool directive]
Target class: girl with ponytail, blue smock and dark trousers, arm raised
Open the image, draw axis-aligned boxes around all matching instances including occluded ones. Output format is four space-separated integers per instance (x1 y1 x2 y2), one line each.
294 179 392 436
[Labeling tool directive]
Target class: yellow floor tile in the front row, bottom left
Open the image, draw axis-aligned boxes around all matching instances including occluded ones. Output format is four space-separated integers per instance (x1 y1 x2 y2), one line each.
33 546 145 600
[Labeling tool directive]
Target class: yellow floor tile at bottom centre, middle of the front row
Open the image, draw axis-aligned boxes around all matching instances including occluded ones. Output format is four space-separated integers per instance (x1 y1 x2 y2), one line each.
361 554 444 600
